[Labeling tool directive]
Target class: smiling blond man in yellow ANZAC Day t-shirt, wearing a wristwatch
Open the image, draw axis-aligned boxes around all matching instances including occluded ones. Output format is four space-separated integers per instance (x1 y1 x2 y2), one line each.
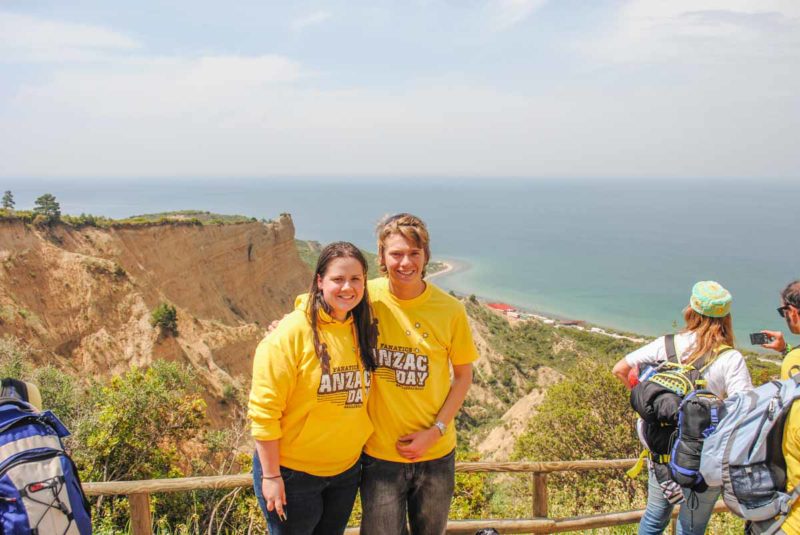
361 214 478 535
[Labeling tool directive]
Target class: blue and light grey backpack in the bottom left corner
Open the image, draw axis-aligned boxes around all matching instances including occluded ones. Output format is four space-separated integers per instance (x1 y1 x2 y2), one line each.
0 379 92 535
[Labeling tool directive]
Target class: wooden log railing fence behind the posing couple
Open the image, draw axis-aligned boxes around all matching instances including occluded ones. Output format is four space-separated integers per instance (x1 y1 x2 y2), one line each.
83 459 727 535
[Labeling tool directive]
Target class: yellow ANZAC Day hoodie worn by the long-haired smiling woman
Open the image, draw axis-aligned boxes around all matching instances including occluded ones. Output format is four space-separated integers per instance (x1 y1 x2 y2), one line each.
247 310 372 476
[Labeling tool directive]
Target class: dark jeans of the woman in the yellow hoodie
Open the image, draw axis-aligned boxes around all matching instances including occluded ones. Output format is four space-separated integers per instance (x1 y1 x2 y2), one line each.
253 455 361 535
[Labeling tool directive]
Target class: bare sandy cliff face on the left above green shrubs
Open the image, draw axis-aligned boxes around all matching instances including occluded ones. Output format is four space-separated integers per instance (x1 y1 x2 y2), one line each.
0 216 310 420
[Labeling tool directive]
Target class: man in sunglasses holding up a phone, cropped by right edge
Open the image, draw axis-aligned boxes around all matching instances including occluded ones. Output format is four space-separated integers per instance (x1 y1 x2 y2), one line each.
763 280 800 535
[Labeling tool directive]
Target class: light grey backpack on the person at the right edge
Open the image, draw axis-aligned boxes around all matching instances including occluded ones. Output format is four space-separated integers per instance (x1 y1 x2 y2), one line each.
700 375 800 533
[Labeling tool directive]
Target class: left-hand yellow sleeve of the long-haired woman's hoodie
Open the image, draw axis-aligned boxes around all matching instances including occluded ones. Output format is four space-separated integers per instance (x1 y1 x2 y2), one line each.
247 330 297 440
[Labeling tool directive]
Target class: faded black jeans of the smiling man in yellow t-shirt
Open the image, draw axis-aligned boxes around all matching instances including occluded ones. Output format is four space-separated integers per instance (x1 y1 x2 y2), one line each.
361 450 456 535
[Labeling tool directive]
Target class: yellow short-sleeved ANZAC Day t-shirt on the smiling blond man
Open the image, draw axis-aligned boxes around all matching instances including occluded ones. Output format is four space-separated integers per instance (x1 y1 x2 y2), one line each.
365 278 478 462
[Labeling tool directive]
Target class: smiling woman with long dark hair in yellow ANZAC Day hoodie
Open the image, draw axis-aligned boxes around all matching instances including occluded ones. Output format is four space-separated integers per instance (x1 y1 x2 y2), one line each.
248 242 376 535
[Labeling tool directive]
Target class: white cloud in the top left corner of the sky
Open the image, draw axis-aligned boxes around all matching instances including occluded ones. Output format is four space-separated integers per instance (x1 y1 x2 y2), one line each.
0 11 141 63
